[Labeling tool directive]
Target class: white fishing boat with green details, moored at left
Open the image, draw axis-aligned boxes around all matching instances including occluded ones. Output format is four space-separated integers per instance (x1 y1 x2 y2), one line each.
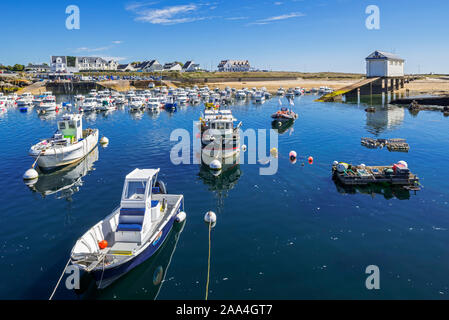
29 114 99 170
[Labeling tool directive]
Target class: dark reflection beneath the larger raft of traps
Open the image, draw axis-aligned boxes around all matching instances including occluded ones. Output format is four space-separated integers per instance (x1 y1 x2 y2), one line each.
334 180 410 200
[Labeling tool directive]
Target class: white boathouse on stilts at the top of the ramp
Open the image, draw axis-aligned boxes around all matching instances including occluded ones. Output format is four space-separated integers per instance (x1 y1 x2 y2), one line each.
366 51 405 78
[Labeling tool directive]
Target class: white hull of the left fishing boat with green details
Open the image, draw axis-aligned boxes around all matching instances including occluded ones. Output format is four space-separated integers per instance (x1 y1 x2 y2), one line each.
30 129 99 171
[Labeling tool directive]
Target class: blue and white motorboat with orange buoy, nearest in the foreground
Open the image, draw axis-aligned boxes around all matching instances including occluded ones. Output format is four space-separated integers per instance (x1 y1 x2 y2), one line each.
71 169 186 289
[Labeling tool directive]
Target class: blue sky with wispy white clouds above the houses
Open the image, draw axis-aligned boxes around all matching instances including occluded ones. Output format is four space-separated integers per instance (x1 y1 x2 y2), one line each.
0 0 449 73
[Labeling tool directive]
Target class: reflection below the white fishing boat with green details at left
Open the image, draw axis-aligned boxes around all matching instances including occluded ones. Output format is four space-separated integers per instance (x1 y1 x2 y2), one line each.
28 147 98 200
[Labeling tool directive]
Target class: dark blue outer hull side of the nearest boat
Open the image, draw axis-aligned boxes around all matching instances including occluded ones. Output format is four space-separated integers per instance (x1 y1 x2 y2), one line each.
91 214 175 289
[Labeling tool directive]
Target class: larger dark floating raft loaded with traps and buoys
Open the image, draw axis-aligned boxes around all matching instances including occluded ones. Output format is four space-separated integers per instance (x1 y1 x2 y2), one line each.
332 161 420 191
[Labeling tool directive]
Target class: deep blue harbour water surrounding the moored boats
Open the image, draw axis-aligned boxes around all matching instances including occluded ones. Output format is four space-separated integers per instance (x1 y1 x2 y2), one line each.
0 96 449 299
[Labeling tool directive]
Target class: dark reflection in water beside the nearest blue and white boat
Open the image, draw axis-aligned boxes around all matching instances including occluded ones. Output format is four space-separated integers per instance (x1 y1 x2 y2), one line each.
75 221 185 300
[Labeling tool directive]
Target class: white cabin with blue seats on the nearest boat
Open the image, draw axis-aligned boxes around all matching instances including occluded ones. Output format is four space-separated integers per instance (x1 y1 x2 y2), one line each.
115 169 164 243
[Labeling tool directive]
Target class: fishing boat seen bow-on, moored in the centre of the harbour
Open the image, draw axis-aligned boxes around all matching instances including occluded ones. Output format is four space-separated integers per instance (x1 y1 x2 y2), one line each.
200 108 242 159
